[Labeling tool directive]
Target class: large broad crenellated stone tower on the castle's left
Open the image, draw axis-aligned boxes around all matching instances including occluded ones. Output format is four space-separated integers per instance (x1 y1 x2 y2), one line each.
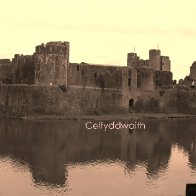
34 42 69 87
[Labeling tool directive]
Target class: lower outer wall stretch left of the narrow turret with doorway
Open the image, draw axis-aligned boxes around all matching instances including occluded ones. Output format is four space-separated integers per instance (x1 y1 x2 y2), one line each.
0 85 122 116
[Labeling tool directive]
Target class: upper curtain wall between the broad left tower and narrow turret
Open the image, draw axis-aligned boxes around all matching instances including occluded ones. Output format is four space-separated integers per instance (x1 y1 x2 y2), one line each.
68 63 122 89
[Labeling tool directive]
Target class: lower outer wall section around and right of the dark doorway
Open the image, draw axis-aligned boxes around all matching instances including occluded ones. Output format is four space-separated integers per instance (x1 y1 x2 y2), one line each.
122 89 193 114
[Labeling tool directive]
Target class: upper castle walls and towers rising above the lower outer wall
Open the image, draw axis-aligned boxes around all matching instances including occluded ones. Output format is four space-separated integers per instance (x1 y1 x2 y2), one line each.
0 42 174 90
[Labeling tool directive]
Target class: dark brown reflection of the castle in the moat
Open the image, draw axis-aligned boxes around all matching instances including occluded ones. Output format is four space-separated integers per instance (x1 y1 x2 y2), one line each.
0 119 196 185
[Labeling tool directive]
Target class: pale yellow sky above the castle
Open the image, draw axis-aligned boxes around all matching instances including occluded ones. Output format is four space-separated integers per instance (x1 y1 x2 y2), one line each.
0 0 196 80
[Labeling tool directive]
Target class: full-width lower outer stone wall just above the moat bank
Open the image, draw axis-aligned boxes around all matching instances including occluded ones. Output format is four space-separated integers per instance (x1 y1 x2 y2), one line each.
0 85 196 116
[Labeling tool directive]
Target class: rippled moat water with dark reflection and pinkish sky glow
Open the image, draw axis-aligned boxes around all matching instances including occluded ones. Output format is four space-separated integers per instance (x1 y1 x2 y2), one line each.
0 119 196 196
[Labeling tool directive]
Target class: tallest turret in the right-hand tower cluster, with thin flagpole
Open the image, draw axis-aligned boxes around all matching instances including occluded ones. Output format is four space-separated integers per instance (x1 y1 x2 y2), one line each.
149 49 161 70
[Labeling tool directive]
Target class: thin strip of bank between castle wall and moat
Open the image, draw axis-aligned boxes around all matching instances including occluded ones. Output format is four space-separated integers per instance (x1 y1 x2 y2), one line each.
0 113 196 121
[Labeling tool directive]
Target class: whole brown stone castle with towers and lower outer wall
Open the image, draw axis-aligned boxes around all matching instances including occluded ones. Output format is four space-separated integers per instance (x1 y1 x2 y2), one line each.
0 42 196 116
